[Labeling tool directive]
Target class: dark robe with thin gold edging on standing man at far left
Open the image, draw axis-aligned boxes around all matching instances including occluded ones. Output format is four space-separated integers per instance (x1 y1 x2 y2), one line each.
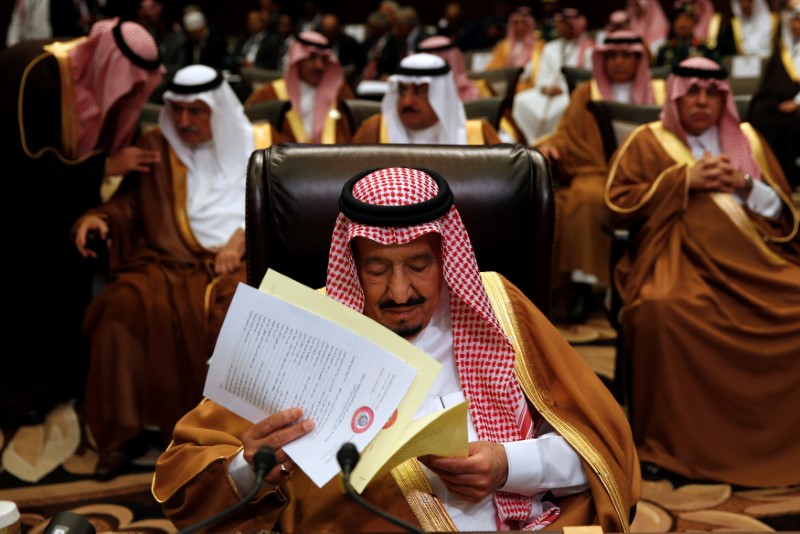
0 40 113 422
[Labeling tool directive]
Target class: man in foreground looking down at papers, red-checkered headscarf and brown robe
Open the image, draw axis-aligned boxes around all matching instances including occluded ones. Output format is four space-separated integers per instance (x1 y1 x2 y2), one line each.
153 168 640 532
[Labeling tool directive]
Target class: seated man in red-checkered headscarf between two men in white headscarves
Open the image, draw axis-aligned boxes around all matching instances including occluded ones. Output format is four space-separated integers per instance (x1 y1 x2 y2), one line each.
245 31 355 145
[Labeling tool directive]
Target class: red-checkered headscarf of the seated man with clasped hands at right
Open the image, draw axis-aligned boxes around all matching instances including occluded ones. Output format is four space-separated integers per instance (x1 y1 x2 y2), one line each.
661 57 761 180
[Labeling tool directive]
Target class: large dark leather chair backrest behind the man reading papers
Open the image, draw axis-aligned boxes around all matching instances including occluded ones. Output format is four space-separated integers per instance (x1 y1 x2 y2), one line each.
246 144 555 314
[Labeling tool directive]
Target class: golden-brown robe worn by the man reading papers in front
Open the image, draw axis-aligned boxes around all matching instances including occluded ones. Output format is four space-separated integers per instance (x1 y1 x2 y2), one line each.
153 273 641 532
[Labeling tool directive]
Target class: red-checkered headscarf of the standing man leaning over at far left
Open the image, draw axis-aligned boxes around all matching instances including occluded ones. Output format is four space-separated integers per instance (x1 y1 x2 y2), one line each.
69 18 164 156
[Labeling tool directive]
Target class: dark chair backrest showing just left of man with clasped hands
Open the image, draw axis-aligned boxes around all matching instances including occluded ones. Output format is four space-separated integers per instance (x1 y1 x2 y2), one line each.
587 100 661 160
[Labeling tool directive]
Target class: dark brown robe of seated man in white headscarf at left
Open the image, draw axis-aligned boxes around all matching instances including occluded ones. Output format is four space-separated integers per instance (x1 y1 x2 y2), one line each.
83 125 272 452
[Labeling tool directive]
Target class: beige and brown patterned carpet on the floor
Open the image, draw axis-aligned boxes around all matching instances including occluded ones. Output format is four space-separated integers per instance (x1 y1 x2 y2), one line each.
0 316 800 534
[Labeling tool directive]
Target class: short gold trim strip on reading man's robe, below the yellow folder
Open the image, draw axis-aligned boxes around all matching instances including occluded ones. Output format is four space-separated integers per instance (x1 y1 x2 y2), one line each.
391 458 458 532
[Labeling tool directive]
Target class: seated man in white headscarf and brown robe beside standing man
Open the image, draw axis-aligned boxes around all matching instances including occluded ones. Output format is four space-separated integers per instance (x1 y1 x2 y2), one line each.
74 65 280 479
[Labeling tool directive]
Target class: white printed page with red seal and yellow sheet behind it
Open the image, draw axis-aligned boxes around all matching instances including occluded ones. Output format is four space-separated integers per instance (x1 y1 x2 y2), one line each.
203 271 454 487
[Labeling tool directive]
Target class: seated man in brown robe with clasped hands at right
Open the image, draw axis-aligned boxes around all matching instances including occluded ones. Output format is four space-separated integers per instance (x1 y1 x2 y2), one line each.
605 58 800 487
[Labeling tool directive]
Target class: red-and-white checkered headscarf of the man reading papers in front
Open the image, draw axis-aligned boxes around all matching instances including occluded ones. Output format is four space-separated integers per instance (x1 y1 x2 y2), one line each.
327 168 554 530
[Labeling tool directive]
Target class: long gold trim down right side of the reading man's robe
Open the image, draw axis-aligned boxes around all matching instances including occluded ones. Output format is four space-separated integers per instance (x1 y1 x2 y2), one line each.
481 272 630 532
